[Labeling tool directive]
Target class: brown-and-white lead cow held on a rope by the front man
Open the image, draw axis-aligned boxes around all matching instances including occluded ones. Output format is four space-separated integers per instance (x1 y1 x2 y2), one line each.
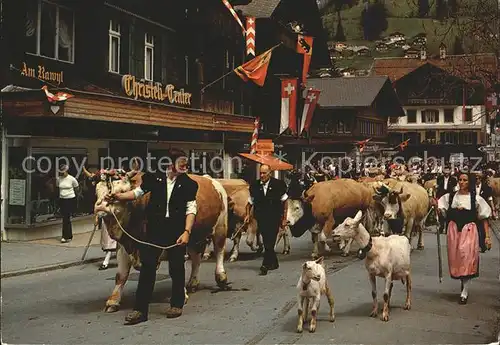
84 169 228 312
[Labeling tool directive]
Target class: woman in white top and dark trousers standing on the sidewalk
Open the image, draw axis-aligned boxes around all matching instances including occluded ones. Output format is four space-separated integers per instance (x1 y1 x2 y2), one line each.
56 165 78 243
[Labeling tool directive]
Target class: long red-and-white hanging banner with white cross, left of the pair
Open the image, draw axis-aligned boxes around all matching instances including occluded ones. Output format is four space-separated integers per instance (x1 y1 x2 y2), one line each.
280 78 297 134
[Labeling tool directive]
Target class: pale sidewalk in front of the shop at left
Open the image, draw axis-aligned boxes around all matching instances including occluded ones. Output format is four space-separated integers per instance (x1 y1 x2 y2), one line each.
0 230 105 278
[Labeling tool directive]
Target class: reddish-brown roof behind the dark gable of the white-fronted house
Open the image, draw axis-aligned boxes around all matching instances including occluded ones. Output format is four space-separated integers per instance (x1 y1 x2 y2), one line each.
372 54 498 81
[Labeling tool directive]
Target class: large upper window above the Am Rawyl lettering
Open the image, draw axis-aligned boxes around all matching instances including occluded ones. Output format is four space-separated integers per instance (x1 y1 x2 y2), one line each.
25 0 75 63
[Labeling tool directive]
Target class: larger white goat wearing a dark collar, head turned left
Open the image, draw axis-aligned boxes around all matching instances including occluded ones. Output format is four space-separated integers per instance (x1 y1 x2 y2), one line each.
333 211 411 321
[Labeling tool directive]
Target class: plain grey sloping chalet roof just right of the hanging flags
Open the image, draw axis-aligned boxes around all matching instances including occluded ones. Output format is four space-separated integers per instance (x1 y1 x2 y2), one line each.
304 76 389 108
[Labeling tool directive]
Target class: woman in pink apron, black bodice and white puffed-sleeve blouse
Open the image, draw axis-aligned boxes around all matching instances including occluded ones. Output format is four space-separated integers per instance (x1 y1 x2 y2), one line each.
438 173 491 304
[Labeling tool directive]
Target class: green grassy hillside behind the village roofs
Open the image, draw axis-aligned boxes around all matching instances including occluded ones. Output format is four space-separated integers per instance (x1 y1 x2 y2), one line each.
323 0 462 69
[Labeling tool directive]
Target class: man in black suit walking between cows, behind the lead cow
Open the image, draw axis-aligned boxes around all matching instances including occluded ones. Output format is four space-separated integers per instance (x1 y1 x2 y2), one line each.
245 164 288 275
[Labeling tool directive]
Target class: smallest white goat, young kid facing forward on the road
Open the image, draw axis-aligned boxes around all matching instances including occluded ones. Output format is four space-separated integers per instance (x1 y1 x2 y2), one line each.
297 257 335 333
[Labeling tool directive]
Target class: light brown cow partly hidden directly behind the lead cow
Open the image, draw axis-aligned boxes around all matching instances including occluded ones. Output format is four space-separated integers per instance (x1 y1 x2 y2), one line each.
203 179 263 262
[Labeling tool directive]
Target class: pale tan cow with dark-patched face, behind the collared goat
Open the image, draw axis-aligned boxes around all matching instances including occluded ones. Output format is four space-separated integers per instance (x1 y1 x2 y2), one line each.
373 179 431 249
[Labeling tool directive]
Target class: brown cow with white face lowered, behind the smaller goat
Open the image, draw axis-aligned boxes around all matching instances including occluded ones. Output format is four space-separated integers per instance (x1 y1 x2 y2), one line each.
287 179 373 259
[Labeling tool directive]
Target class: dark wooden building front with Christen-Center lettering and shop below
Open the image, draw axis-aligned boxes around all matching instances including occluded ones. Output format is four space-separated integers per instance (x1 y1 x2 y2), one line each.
0 0 254 240
